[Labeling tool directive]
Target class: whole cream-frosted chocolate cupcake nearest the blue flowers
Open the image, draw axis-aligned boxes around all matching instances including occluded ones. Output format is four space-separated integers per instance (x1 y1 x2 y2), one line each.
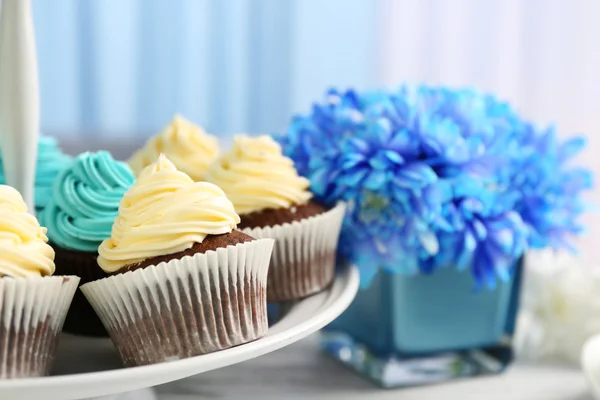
206 136 345 302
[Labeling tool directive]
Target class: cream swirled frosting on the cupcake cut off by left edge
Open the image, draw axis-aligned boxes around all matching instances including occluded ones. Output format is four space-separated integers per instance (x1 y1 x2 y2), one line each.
0 185 54 278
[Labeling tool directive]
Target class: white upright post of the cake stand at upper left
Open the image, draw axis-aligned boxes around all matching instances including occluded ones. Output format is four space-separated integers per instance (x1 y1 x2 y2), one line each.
0 0 39 213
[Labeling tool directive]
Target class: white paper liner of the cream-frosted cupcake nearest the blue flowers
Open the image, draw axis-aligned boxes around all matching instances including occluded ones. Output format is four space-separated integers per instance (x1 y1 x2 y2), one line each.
242 203 346 302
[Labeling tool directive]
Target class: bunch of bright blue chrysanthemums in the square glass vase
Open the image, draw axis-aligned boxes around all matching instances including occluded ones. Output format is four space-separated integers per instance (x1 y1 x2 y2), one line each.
278 86 591 287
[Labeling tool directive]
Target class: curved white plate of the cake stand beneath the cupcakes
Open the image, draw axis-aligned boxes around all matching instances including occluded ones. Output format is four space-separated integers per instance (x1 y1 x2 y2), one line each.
0 268 359 400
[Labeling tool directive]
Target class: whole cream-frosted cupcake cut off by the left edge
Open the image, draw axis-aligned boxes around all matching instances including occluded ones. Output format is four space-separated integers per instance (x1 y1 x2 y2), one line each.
0 185 79 379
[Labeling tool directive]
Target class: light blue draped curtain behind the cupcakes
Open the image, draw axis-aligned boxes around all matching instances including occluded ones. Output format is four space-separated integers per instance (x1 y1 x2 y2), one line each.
32 0 381 138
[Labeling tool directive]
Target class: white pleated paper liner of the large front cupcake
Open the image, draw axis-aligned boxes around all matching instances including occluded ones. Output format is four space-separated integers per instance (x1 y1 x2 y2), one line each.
81 239 273 366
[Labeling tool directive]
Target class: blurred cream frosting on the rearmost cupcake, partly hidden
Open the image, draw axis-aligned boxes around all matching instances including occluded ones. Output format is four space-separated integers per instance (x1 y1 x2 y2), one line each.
129 115 219 181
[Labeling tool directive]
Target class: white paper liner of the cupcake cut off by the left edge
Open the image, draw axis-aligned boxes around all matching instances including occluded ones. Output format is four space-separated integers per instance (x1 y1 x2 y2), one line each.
0 276 79 378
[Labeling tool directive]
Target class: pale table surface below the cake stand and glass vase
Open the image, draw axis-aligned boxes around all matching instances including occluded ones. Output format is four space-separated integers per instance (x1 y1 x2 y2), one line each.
158 336 593 400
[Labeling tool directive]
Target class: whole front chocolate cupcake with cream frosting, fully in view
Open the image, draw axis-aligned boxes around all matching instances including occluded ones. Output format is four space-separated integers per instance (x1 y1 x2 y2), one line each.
81 155 273 366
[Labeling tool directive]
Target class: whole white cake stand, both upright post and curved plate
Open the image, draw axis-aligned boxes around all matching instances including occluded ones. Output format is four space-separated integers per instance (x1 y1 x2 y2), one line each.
0 0 358 400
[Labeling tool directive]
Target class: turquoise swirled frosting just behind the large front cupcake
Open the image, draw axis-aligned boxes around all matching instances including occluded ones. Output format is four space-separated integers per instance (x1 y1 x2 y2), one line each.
40 151 135 253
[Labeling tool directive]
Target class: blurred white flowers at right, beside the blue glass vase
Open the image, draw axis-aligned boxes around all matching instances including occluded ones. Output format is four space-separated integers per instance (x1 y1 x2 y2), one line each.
514 250 600 366
